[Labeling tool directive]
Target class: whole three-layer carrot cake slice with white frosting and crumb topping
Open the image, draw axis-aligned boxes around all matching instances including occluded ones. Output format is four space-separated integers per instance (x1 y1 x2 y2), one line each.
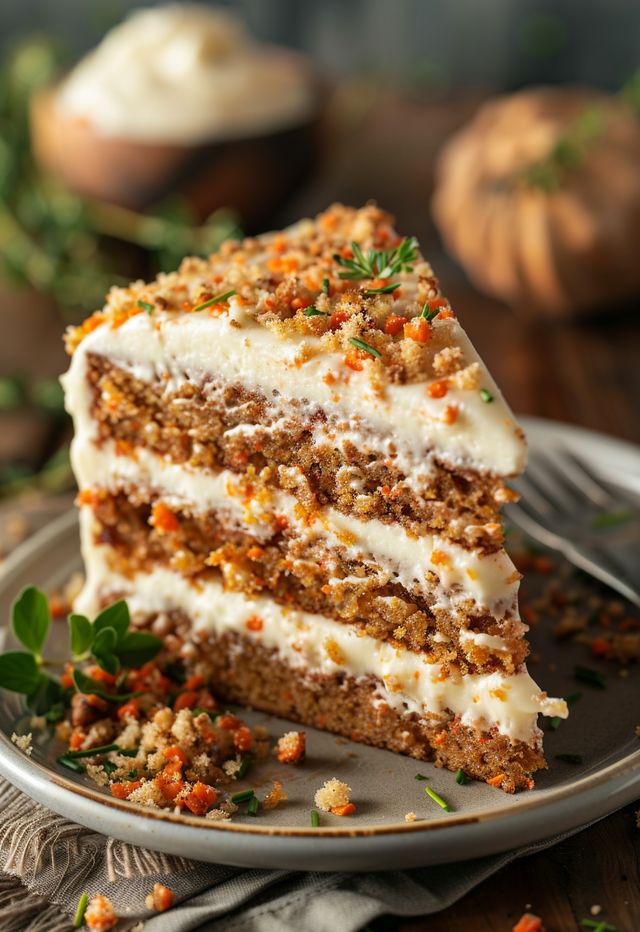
64 205 566 789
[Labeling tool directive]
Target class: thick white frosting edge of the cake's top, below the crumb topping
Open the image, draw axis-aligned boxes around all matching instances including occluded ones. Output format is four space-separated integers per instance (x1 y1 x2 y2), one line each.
64 297 526 476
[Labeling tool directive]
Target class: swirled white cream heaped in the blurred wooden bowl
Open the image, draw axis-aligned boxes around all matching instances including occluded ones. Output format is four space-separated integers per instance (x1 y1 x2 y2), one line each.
58 4 314 144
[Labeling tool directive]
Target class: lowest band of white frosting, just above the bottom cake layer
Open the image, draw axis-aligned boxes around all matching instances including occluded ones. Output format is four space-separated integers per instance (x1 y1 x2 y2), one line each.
75 510 567 743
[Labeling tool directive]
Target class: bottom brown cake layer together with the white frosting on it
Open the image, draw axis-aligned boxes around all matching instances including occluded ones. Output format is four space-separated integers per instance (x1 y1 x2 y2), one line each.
77 555 564 787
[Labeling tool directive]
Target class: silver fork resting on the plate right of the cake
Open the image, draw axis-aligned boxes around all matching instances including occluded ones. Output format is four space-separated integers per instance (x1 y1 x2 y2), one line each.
506 447 640 607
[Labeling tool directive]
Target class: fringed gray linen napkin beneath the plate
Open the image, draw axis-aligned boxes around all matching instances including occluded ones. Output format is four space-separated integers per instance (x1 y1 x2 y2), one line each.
0 781 600 932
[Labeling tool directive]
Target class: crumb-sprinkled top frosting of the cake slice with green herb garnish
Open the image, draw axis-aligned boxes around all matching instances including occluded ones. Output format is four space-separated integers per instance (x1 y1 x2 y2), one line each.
68 205 526 476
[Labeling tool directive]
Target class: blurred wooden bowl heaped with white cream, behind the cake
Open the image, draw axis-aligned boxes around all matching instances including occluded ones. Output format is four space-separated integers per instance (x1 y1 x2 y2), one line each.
31 5 323 229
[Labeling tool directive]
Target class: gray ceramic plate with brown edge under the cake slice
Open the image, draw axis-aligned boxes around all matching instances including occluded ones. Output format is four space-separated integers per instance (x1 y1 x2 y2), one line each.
0 420 640 870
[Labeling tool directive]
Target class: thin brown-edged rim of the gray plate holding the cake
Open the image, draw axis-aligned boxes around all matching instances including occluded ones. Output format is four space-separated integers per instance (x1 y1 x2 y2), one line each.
0 416 640 869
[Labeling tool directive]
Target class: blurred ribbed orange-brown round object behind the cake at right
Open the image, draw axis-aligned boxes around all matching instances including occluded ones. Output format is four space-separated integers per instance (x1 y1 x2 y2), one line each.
432 87 640 317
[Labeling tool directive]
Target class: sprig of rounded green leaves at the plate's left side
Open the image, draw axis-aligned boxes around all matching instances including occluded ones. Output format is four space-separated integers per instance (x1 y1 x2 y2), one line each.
0 586 162 721
